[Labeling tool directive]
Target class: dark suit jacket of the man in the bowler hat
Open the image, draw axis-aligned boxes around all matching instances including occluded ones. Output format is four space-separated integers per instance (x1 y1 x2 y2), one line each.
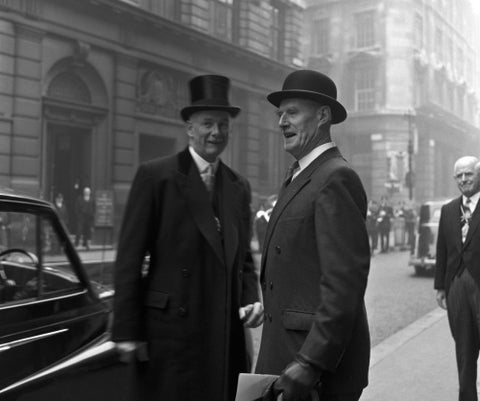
256 148 370 393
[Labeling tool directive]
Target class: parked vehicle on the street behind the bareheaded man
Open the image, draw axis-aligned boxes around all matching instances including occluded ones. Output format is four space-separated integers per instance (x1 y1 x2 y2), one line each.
408 199 450 275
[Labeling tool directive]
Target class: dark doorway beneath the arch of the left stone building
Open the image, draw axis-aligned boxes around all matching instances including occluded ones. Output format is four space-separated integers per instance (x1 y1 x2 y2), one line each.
47 125 92 232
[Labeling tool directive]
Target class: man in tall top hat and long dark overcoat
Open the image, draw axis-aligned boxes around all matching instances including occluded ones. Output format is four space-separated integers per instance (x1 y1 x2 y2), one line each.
113 75 263 401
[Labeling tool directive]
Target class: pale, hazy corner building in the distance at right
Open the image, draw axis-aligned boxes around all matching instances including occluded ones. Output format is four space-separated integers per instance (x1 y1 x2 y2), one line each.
304 0 480 203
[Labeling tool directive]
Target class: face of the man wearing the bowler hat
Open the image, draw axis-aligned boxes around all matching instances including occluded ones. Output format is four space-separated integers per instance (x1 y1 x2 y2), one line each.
277 99 322 160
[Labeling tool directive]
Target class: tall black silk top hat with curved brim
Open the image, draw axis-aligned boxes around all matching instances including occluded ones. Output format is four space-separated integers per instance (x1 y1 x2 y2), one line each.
180 75 240 121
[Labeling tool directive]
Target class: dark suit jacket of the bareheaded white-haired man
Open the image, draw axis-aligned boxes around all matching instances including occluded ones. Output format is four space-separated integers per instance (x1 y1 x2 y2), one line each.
434 196 480 295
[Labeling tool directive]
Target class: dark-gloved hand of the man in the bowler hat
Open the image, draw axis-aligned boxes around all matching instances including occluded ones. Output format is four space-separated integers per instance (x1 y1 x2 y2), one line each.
274 361 321 401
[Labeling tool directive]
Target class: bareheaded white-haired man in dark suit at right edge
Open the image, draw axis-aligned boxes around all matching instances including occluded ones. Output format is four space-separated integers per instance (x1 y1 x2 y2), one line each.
434 156 480 401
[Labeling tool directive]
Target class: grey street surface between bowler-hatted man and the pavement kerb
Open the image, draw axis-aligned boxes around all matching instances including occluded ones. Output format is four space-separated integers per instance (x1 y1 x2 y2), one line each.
252 251 437 355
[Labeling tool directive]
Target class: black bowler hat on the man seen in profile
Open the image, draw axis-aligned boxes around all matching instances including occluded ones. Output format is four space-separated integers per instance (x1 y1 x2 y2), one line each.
267 70 347 124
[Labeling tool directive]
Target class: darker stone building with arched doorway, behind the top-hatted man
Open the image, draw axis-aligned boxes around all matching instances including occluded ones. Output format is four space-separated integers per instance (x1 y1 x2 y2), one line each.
0 0 303 238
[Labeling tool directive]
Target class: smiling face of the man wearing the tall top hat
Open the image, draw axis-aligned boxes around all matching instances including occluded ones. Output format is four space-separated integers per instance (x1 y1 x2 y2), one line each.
187 110 230 162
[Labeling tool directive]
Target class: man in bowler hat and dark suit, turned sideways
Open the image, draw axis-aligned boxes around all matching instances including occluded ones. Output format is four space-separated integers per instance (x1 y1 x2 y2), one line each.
256 70 370 401
